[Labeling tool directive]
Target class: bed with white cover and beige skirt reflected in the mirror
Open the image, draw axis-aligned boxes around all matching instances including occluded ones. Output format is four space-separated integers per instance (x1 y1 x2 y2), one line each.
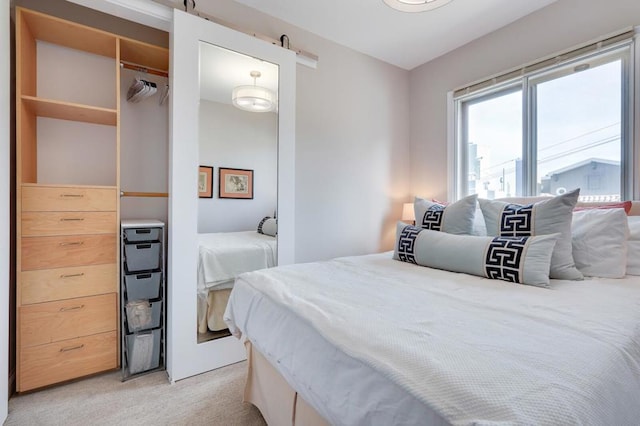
198 231 276 333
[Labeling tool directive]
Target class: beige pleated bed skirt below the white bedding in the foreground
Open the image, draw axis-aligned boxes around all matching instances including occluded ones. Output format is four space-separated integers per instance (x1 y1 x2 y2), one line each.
244 340 329 426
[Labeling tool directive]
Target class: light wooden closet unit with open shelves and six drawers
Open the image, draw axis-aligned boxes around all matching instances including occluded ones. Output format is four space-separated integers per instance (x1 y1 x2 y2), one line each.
16 8 169 392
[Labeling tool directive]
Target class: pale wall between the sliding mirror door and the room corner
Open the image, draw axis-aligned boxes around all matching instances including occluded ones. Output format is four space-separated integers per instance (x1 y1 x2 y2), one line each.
198 0 410 262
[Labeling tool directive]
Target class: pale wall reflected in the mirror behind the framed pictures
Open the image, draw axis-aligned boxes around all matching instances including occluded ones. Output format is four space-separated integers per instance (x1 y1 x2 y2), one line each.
198 100 278 232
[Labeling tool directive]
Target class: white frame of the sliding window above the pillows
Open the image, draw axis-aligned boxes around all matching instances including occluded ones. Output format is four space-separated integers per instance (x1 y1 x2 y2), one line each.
447 36 640 200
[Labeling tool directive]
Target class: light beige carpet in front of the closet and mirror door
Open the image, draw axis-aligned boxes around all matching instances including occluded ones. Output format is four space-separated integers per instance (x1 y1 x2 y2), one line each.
5 362 265 426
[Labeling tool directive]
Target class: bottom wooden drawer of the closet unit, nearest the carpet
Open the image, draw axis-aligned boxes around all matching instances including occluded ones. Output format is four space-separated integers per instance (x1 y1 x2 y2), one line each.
18 331 118 392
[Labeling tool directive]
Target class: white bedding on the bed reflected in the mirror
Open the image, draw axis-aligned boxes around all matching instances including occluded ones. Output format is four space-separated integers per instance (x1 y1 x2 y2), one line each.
198 231 276 297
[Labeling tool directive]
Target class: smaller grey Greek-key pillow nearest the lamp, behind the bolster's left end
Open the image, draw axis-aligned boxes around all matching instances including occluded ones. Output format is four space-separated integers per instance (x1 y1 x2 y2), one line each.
413 194 478 235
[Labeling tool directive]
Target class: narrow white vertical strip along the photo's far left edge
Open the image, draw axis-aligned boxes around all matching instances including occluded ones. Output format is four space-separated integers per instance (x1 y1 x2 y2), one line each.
0 0 11 423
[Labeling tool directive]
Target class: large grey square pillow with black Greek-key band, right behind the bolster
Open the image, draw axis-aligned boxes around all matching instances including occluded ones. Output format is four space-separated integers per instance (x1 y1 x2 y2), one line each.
478 189 583 280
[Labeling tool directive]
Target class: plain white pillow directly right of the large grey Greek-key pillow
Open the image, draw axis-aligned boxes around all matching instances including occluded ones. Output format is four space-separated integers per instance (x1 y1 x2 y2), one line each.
571 208 629 278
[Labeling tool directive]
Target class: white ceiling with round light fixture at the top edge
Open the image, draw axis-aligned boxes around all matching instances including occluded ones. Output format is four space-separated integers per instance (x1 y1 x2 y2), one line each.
235 0 556 70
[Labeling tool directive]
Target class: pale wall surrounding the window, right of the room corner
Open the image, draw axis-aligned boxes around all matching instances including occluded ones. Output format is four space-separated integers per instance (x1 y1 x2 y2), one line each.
411 0 640 199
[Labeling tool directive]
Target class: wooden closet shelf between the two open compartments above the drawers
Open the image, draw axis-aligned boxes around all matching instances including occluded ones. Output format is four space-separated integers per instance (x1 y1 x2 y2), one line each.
22 95 118 126
